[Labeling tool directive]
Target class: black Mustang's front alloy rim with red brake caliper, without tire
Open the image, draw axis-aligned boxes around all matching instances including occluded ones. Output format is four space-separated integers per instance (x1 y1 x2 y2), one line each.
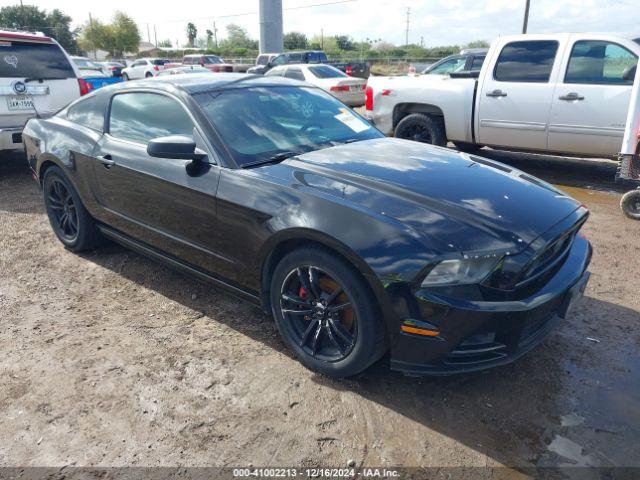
280 265 358 362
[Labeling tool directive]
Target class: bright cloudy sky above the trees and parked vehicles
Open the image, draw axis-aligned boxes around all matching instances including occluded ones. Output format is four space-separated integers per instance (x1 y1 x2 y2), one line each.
20 0 640 46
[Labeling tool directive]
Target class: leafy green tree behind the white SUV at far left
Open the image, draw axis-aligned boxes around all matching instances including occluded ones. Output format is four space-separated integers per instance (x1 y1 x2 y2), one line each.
0 5 79 53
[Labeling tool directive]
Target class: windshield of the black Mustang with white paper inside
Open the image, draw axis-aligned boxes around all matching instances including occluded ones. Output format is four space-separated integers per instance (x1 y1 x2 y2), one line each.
195 86 383 166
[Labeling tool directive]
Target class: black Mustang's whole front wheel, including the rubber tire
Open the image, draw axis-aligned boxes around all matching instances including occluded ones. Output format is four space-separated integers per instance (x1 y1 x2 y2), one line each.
270 248 386 377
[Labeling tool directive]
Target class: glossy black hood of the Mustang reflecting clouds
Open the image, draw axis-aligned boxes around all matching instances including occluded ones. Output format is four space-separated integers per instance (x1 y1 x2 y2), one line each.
264 138 580 253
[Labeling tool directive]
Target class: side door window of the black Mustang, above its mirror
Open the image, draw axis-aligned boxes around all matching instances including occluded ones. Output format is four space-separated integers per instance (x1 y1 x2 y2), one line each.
109 93 194 144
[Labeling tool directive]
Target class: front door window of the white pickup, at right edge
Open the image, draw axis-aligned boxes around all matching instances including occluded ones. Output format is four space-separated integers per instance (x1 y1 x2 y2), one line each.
564 40 638 85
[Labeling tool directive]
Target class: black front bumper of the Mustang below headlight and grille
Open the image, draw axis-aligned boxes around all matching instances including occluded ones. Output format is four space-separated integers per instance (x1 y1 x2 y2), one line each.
391 236 592 375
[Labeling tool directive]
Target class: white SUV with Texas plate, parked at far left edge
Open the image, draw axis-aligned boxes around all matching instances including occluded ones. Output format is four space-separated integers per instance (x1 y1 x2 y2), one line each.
0 30 84 156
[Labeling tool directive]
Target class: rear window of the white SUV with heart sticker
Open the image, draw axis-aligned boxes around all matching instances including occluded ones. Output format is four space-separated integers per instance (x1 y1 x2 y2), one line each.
0 41 75 79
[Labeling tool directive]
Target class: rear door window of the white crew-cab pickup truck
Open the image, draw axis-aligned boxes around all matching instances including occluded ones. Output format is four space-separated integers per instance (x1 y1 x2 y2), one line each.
493 40 558 83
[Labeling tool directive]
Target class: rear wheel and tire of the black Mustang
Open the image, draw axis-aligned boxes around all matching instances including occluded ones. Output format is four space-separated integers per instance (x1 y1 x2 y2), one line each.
42 166 101 252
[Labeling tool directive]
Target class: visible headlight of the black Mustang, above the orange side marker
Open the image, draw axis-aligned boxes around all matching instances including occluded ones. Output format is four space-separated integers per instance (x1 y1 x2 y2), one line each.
421 257 500 287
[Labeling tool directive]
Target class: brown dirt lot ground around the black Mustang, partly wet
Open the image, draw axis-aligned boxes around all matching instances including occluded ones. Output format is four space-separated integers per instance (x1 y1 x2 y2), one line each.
0 152 640 478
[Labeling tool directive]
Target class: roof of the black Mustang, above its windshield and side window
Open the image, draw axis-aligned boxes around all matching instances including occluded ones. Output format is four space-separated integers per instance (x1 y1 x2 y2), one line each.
100 73 309 95
